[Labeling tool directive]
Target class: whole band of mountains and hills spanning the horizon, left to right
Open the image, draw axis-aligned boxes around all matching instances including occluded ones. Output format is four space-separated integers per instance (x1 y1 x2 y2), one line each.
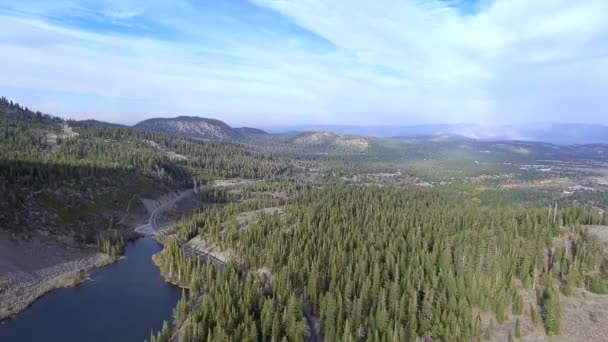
0 93 608 167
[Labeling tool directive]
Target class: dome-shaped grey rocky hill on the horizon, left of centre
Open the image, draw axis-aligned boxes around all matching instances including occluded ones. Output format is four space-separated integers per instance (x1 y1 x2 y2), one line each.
134 116 267 140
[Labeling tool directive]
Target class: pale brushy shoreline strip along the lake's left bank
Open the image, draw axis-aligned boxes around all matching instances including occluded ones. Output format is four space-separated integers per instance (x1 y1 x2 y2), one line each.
0 252 115 322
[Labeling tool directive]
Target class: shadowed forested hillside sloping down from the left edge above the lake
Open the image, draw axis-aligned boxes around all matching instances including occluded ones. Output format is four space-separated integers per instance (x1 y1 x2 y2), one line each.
0 98 295 242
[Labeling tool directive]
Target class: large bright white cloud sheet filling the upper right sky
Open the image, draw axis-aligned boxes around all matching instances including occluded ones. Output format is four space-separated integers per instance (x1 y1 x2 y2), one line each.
255 0 608 121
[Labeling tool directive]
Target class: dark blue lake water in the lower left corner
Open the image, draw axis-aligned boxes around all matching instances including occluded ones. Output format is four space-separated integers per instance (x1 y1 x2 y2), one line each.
0 238 181 342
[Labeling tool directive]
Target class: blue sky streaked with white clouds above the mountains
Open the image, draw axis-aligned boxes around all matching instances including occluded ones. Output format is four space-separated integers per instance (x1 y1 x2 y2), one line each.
0 0 608 127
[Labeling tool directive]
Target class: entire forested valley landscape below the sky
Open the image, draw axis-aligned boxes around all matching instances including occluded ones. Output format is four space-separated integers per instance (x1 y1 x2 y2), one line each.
0 99 608 341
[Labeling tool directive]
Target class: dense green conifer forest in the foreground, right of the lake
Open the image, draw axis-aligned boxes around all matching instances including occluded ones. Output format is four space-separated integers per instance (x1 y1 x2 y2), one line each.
152 185 608 341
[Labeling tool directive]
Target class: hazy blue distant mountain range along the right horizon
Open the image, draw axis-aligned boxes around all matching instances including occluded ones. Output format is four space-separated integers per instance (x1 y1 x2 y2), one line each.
269 124 608 144
